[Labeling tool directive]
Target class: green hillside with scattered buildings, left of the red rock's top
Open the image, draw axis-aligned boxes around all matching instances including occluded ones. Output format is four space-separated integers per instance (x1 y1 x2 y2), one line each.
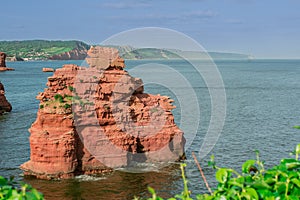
0 40 89 60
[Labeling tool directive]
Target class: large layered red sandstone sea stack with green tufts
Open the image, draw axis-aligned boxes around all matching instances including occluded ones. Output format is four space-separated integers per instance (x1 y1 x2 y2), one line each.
21 47 185 179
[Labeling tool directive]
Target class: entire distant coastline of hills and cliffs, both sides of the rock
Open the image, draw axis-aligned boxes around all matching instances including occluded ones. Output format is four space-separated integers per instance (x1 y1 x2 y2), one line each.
0 40 250 61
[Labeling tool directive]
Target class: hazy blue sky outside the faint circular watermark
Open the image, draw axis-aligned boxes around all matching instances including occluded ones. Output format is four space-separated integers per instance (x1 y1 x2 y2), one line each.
0 0 300 58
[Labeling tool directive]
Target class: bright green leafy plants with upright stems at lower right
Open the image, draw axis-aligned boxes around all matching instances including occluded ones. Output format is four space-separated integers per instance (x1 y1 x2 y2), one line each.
141 144 300 200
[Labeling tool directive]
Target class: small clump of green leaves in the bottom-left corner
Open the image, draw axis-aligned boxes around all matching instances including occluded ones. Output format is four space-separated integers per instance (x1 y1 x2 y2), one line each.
0 176 44 200
